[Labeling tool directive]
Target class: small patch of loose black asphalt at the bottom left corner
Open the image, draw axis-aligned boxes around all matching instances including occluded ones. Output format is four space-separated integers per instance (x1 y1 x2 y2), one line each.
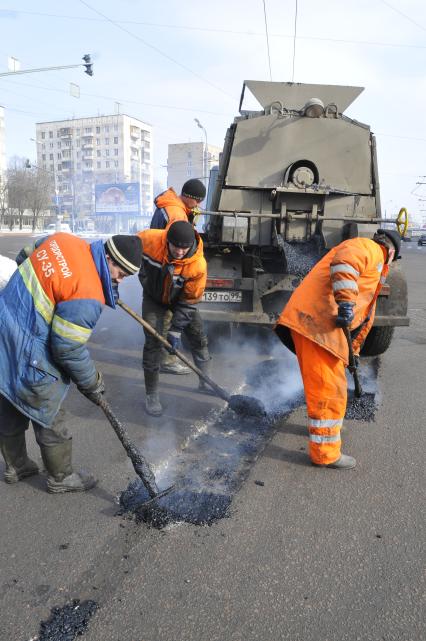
37 599 98 641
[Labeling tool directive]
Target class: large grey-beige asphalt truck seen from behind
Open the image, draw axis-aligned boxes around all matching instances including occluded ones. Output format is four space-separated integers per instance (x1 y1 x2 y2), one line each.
200 80 409 355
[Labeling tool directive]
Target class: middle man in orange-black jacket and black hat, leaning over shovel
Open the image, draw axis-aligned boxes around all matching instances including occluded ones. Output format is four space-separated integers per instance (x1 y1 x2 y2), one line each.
137 220 210 416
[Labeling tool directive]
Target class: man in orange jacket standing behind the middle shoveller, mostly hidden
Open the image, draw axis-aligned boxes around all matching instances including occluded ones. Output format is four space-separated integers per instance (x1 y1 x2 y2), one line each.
151 178 206 374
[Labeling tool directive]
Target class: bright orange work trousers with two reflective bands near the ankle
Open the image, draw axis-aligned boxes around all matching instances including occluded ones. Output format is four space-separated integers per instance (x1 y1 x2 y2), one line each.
291 330 348 465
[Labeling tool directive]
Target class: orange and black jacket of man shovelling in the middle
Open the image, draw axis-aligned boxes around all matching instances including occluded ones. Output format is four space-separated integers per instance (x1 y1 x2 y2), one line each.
137 229 207 329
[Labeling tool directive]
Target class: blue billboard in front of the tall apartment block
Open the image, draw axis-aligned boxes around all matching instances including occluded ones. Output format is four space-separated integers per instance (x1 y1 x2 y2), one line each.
95 183 140 216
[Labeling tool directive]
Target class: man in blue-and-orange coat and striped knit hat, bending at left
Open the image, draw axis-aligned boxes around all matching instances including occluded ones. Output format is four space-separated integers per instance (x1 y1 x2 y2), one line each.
0 233 142 493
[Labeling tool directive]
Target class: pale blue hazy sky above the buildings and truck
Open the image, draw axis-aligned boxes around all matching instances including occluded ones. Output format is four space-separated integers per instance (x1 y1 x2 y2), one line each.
0 0 426 221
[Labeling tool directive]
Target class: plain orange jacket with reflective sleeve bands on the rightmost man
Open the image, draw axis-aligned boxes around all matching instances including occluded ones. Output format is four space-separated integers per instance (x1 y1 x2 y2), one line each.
275 238 389 365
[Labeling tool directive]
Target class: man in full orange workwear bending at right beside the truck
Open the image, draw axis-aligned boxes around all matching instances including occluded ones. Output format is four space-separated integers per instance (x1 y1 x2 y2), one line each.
275 229 401 469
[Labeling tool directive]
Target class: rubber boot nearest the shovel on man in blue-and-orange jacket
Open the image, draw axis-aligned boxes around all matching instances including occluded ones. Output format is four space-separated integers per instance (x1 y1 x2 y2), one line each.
40 439 97 494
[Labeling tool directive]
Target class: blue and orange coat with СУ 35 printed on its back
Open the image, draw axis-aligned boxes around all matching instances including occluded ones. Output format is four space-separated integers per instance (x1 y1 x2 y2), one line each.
0 233 115 427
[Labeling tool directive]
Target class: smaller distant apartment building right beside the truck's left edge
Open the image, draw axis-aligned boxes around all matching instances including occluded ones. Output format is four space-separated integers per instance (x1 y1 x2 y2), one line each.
167 142 222 193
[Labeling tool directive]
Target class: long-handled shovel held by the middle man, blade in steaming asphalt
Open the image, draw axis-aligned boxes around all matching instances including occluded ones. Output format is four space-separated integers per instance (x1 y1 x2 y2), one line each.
117 299 266 416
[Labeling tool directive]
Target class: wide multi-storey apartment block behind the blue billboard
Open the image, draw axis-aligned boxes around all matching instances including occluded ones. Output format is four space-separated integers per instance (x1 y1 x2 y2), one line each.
36 114 153 221
